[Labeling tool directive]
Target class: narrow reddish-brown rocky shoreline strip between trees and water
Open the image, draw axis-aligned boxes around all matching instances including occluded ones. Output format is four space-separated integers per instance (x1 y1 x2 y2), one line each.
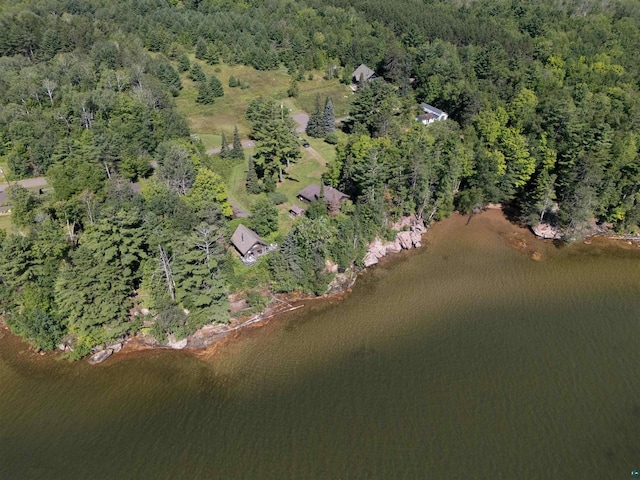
0 205 640 365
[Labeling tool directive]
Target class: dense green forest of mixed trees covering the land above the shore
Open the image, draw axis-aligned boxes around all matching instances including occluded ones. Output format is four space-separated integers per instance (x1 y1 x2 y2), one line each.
0 0 640 357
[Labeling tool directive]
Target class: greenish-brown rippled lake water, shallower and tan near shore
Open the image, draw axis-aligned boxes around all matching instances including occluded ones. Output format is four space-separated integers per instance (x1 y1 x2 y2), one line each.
0 212 640 480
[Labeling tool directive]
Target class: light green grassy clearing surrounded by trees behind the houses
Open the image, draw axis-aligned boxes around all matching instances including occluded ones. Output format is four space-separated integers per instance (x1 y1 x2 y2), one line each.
176 56 351 233
